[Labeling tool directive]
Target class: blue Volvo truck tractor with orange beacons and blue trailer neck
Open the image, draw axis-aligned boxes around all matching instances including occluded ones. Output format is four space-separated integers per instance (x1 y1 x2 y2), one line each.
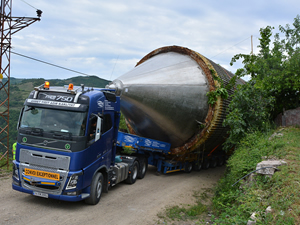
12 82 170 205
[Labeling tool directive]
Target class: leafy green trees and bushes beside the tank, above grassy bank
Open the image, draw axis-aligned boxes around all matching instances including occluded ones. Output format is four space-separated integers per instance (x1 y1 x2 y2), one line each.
224 15 300 150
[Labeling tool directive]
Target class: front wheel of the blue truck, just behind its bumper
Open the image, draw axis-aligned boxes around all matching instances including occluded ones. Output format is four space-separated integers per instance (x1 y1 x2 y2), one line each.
85 173 104 205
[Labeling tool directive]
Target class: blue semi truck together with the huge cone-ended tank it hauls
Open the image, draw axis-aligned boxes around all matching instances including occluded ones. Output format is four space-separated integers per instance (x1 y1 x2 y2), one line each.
12 46 245 205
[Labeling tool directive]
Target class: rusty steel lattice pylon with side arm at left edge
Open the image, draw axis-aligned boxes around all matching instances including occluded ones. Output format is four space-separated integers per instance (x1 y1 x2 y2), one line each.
0 0 42 169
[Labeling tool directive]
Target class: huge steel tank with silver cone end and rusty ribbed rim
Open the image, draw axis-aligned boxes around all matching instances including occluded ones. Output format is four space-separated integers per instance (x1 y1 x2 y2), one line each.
108 46 243 155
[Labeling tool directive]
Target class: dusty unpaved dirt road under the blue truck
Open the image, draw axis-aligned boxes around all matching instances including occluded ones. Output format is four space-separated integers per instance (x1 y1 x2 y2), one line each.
0 166 225 225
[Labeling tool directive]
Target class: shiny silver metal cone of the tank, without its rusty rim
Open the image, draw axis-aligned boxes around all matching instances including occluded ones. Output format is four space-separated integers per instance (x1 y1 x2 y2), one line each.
108 46 209 147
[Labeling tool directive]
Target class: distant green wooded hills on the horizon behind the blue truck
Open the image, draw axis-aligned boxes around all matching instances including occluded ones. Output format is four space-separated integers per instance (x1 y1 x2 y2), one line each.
0 76 109 153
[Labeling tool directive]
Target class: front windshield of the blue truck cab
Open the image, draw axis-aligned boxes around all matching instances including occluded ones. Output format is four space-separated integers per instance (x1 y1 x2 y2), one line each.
20 106 86 136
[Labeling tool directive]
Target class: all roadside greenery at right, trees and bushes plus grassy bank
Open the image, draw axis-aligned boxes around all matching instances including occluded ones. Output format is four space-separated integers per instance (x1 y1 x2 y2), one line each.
159 15 300 224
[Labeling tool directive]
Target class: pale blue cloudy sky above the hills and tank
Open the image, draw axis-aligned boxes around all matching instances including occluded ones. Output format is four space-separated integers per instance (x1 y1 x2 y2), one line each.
6 0 300 80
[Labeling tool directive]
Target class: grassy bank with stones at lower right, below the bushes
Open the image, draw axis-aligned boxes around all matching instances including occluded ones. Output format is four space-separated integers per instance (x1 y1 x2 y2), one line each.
159 127 300 225
